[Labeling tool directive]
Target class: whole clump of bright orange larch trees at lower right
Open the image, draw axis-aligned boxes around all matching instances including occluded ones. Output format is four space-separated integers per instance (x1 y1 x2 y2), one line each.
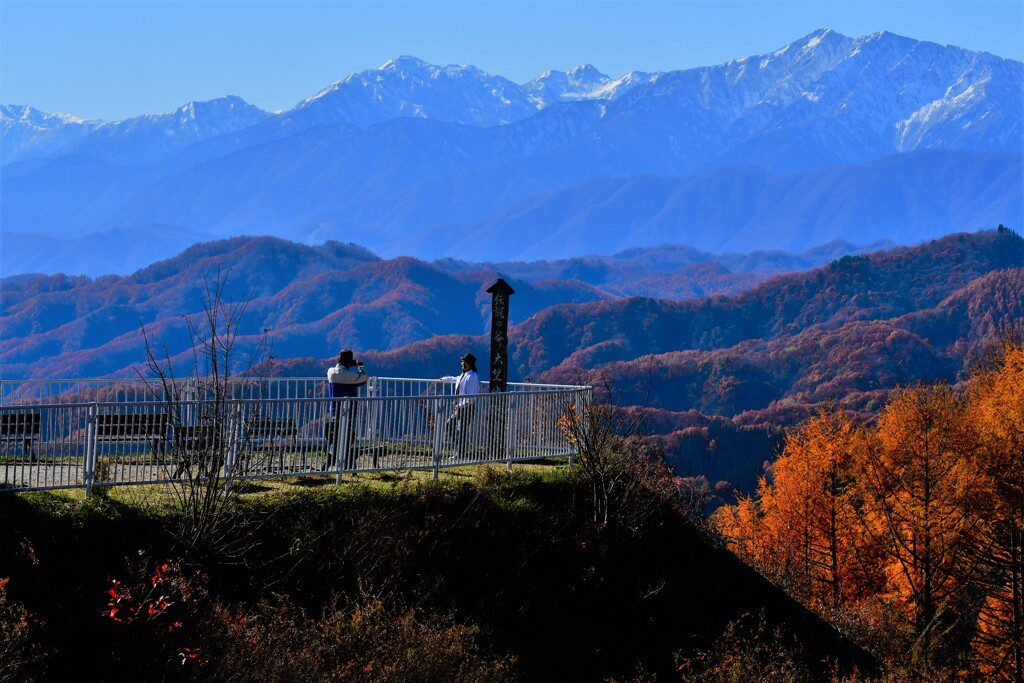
714 341 1024 681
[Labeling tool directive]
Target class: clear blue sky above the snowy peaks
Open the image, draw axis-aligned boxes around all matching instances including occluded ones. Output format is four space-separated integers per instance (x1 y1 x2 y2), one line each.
0 0 1024 120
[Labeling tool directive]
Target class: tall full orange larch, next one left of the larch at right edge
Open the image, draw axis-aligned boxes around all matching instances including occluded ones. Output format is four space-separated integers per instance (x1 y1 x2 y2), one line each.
858 384 983 667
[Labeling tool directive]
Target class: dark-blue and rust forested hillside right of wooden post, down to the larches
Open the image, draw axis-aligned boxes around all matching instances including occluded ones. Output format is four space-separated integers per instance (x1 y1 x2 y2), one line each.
354 228 1024 490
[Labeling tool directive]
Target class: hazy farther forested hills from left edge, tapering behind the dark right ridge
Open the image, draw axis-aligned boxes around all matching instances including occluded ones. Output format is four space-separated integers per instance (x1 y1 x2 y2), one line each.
0 236 878 379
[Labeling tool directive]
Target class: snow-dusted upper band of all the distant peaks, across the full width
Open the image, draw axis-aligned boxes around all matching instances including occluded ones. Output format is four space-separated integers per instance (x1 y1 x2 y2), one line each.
6 29 1022 167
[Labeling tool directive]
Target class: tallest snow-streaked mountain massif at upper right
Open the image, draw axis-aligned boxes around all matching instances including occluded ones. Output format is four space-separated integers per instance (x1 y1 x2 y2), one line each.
589 30 1024 172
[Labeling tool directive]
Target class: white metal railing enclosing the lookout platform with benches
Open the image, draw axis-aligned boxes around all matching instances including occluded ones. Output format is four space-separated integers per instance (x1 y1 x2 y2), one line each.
0 378 591 493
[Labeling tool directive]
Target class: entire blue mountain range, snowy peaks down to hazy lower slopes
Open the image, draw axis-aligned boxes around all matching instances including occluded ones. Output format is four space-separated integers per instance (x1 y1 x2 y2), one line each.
0 30 1024 275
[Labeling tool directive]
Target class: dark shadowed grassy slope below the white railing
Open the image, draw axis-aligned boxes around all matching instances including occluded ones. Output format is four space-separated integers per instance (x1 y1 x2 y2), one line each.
0 472 869 680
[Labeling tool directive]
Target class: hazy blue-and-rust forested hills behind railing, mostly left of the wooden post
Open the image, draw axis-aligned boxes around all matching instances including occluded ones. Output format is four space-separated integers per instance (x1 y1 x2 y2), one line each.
0 238 612 378
